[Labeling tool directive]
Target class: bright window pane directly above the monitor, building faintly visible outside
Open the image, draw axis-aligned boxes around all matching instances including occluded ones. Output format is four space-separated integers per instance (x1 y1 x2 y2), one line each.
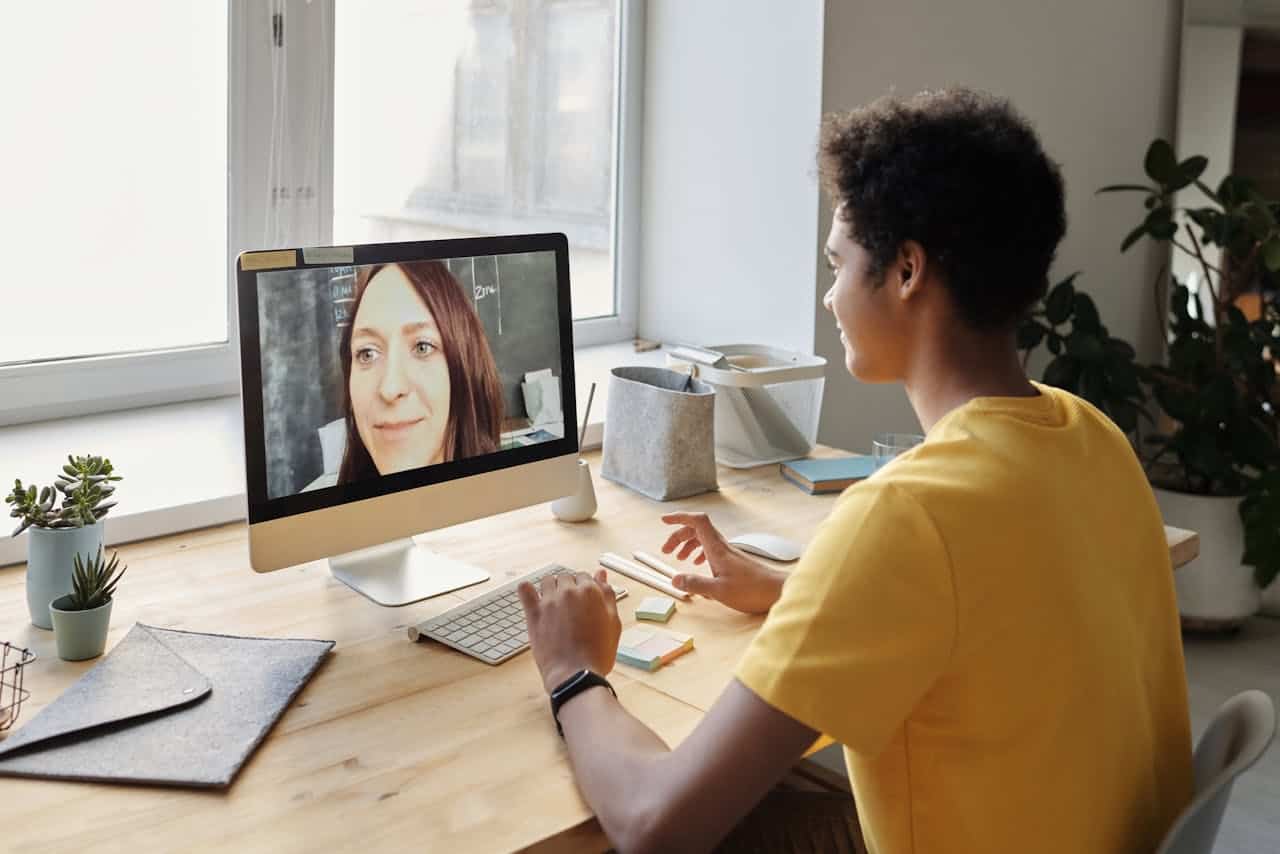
333 0 621 320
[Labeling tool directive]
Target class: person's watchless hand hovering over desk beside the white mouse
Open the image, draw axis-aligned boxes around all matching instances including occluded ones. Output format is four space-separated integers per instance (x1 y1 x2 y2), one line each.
662 513 787 613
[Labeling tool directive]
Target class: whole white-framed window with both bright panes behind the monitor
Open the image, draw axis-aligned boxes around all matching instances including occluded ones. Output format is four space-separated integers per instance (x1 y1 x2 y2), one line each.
0 0 643 424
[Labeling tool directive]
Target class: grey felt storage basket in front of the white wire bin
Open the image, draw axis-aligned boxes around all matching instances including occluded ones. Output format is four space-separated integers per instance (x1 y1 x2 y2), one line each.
600 367 717 501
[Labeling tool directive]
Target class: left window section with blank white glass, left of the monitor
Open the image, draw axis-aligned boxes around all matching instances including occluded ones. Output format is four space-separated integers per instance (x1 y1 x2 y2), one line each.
0 0 234 424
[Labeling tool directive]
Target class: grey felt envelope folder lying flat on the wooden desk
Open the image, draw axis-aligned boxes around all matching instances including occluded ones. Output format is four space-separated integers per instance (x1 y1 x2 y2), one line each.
0 624 334 787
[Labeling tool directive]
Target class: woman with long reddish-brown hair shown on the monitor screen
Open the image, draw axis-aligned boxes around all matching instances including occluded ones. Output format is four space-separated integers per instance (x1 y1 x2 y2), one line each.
338 261 502 483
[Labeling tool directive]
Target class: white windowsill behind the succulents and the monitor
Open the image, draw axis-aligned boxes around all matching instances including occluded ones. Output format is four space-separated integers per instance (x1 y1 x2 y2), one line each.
0 342 666 566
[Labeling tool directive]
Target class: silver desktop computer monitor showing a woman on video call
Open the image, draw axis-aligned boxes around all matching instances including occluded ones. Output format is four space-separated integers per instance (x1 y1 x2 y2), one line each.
236 234 579 606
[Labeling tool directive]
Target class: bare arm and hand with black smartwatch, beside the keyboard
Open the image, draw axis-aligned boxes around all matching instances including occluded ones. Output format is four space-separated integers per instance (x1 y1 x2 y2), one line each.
520 572 817 851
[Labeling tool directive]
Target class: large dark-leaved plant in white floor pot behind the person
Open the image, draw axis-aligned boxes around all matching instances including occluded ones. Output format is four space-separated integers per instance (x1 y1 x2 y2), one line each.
1019 140 1280 629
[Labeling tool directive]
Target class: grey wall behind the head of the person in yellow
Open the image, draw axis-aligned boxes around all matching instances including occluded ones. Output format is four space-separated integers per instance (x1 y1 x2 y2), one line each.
810 0 1180 451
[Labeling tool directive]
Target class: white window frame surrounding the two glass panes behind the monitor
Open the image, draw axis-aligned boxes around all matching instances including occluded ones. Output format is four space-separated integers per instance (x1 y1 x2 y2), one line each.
0 0 645 426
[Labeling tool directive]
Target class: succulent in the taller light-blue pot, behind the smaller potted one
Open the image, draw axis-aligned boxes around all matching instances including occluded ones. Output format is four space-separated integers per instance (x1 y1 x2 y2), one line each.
5 456 120 629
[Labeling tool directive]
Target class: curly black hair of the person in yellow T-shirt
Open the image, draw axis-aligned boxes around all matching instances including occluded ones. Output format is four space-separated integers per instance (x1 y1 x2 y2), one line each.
818 87 1066 330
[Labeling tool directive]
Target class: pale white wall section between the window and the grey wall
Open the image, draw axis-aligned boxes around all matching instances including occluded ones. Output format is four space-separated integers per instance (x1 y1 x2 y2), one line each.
637 0 823 352
